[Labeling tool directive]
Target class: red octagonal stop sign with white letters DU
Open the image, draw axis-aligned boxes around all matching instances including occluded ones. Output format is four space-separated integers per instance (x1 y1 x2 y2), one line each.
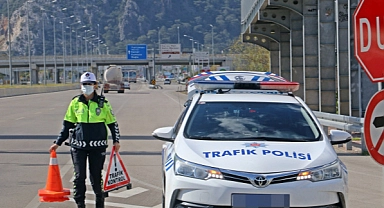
353 0 384 82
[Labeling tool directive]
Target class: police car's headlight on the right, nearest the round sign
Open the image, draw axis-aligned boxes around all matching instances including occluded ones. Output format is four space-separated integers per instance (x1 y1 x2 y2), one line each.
297 160 341 182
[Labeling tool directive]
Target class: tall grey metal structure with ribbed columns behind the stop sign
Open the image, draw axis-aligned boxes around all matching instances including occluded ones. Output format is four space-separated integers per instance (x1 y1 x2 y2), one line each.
241 0 381 117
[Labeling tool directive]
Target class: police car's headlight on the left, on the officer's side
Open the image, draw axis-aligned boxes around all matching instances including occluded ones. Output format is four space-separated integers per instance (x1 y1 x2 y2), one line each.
175 156 223 180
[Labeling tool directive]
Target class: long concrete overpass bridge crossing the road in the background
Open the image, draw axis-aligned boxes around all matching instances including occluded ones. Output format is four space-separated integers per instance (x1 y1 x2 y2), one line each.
0 54 232 83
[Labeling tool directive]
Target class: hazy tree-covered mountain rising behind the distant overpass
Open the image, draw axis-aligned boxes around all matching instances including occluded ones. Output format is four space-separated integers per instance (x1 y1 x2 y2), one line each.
0 0 241 55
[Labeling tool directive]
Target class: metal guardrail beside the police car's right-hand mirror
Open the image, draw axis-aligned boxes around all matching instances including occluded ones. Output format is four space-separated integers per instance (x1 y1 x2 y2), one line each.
313 111 367 153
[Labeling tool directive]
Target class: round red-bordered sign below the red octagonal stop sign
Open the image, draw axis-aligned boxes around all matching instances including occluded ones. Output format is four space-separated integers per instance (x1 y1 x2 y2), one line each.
364 90 384 165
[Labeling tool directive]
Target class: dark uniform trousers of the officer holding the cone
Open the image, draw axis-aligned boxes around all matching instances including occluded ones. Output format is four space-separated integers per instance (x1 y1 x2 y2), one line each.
71 148 106 203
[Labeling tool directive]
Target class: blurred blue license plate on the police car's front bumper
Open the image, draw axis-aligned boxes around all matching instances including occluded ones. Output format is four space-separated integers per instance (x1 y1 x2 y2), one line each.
232 194 290 208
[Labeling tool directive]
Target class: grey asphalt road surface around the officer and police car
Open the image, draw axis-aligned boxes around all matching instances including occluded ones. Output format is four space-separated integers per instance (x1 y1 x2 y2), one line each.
0 82 384 208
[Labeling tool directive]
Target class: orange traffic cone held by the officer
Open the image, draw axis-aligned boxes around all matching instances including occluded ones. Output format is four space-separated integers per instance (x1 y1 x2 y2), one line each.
39 151 70 202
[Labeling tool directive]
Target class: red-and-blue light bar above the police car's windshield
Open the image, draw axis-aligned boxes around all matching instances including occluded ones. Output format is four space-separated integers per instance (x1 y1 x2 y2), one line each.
195 80 300 92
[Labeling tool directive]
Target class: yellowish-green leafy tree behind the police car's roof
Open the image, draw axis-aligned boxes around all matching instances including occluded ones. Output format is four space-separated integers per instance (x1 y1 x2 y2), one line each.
228 37 270 71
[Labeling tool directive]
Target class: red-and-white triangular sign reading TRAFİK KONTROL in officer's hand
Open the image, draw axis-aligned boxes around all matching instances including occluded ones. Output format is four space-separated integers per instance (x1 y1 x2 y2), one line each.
104 146 131 192
